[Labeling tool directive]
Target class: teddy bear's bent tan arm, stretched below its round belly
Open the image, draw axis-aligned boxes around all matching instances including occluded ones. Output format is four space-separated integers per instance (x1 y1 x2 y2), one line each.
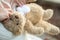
24 20 44 35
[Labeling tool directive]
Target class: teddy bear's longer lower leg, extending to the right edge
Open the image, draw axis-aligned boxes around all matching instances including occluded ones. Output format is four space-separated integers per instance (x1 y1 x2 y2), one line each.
36 20 59 35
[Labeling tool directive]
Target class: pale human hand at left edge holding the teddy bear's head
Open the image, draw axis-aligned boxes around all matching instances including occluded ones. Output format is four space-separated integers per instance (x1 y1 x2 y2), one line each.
0 2 12 21
